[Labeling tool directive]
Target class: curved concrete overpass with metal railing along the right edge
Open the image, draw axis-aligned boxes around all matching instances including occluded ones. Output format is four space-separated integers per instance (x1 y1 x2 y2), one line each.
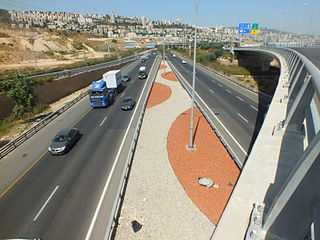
212 47 320 240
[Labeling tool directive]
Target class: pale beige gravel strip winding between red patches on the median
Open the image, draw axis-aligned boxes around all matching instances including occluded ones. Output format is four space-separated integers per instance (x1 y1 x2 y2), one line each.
115 62 214 239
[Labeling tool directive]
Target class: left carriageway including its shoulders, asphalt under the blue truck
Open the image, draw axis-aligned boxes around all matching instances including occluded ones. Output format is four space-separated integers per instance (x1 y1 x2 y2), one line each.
0 55 155 240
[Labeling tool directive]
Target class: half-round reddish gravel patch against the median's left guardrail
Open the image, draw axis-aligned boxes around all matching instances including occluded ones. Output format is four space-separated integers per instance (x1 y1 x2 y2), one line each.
147 82 172 108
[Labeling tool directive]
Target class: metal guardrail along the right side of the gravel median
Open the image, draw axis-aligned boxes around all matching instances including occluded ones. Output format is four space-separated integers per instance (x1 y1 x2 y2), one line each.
167 60 243 169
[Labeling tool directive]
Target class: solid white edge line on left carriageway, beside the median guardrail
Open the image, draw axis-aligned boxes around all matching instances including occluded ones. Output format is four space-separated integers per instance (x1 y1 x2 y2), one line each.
85 55 156 240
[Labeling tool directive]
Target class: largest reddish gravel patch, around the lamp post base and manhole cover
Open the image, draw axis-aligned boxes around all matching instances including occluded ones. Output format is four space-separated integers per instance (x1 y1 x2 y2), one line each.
167 108 240 224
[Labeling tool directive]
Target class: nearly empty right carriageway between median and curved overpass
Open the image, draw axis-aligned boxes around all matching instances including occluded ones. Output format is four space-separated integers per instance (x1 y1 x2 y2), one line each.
167 54 269 163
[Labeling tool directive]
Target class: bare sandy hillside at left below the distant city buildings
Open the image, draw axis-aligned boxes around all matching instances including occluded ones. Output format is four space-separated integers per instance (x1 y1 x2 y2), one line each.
0 24 116 74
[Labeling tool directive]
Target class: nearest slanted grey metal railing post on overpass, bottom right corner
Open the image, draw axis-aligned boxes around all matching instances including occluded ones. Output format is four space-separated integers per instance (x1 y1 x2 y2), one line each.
263 132 320 239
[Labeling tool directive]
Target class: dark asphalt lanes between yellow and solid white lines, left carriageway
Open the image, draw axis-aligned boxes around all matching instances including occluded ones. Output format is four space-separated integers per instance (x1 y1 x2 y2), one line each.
0 53 158 239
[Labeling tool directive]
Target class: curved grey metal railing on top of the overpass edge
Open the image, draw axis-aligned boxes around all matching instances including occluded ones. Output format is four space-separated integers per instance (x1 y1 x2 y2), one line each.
238 47 320 240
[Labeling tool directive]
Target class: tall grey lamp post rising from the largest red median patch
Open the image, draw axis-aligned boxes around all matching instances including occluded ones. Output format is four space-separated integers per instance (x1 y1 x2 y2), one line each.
188 0 199 150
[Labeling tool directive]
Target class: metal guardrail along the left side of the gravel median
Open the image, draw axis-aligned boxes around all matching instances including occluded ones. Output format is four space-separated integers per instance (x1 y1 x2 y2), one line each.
104 57 161 239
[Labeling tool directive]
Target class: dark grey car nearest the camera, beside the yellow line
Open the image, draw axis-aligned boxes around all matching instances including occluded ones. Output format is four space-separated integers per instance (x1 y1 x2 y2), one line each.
48 128 80 155
